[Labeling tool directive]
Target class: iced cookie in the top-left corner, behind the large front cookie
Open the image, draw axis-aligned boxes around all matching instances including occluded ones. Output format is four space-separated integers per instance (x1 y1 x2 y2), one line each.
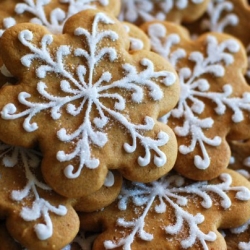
0 0 120 36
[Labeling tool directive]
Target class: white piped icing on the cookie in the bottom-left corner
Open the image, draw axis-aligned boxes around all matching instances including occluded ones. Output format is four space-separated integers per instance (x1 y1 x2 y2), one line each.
0 143 67 240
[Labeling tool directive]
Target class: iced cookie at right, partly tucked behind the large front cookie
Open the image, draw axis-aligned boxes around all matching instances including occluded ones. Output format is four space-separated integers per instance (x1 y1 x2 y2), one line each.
142 22 250 180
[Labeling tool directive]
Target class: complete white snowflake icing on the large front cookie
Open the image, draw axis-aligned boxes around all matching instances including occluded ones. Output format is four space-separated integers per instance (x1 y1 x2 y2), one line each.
1 13 176 178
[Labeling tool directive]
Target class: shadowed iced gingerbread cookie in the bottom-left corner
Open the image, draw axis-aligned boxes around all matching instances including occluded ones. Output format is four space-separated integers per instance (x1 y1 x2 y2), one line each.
0 143 79 249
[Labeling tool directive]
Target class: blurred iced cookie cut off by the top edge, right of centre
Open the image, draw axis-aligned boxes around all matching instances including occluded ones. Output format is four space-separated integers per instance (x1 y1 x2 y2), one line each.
119 0 209 24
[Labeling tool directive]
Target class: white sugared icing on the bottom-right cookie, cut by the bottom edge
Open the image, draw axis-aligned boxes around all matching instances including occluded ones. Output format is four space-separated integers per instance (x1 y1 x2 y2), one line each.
104 173 250 250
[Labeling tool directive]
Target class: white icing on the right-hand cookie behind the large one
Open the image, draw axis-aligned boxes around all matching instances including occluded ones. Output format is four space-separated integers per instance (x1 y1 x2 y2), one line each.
148 23 250 169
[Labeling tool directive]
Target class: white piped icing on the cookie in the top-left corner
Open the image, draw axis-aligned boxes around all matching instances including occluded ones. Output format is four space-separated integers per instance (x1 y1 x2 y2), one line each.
0 0 109 36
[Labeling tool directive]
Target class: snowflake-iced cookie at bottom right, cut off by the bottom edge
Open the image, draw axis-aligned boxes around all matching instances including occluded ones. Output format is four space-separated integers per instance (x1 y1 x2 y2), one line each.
80 170 250 250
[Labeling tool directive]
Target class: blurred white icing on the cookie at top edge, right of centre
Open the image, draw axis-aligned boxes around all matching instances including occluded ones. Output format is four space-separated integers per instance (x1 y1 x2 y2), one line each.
119 0 206 23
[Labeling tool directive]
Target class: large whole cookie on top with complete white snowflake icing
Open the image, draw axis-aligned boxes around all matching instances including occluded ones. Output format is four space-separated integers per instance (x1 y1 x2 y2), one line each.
0 10 179 197
